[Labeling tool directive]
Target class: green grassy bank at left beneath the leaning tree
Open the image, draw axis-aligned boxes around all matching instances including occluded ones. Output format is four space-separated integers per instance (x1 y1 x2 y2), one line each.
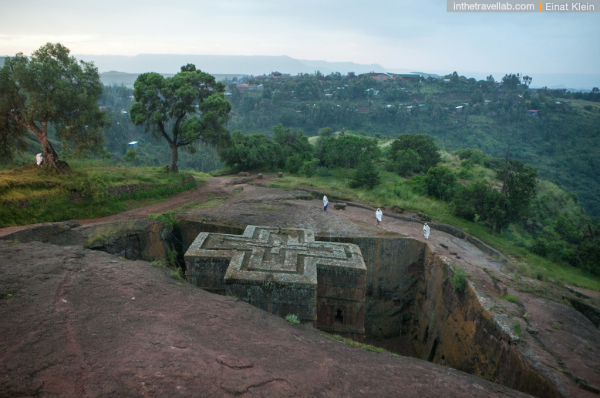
0 161 208 228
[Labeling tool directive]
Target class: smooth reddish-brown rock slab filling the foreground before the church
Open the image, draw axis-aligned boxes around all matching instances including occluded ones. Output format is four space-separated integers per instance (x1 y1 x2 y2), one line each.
0 242 525 397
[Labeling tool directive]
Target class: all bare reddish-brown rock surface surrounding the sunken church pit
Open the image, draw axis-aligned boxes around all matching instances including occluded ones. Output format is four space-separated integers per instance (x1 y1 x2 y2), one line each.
0 176 600 397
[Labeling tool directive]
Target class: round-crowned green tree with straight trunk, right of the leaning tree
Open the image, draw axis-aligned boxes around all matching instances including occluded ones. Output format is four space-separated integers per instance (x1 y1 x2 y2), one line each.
129 64 231 173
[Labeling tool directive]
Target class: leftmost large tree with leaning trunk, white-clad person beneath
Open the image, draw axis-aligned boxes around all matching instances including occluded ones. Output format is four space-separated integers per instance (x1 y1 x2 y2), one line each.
0 43 105 172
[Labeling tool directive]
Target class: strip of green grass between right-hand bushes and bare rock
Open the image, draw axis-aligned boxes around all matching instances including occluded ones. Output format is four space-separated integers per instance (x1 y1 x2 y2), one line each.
268 169 600 291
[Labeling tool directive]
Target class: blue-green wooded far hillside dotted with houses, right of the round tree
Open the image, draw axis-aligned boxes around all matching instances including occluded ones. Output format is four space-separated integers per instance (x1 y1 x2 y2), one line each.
229 75 600 216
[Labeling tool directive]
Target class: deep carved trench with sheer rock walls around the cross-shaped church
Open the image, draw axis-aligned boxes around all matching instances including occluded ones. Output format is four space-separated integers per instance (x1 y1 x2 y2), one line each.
163 219 563 397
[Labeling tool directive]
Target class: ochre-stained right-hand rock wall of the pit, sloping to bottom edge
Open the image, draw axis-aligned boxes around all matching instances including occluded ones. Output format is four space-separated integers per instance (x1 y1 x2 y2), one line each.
412 246 563 397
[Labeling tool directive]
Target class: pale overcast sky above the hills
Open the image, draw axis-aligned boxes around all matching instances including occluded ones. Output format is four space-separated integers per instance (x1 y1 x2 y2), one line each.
0 0 600 75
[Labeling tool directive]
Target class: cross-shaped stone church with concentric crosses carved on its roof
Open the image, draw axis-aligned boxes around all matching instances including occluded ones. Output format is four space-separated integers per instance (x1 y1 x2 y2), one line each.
185 225 367 334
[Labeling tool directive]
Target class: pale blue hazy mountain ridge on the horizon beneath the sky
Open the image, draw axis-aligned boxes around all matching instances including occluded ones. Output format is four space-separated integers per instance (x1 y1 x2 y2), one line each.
75 54 384 75
